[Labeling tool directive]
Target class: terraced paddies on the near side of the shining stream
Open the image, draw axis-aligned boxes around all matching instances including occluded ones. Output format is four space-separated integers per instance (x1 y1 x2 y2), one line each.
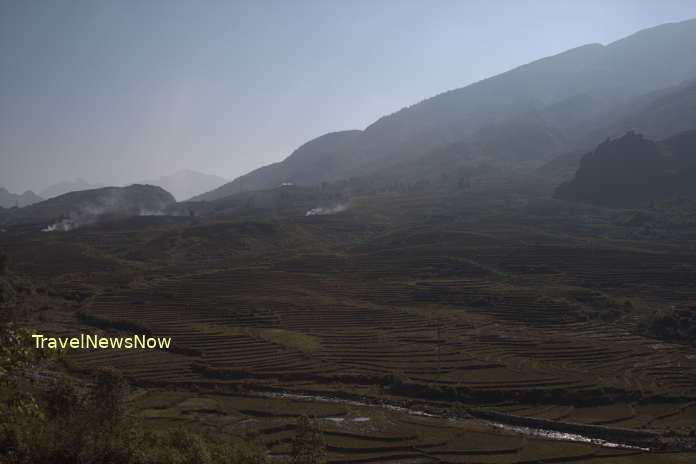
129 390 688 464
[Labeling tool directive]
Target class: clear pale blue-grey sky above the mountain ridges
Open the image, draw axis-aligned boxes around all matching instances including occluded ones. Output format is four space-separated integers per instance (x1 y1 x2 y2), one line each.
0 0 696 193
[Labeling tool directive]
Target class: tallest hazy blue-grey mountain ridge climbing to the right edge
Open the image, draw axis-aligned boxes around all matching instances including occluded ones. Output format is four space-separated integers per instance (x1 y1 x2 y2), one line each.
194 20 696 200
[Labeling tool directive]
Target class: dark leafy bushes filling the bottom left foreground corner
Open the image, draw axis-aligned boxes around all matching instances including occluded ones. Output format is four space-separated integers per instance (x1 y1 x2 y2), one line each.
0 369 267 464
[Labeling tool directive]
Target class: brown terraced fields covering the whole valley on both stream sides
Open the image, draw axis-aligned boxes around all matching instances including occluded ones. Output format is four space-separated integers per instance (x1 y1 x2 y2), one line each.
0 189 696 463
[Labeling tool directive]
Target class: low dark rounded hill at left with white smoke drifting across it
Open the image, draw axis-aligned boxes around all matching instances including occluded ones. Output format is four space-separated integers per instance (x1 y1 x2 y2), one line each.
14 184 176 229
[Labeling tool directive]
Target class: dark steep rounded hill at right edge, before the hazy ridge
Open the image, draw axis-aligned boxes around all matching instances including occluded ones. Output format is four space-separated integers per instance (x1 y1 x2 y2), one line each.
556 130 696 207
